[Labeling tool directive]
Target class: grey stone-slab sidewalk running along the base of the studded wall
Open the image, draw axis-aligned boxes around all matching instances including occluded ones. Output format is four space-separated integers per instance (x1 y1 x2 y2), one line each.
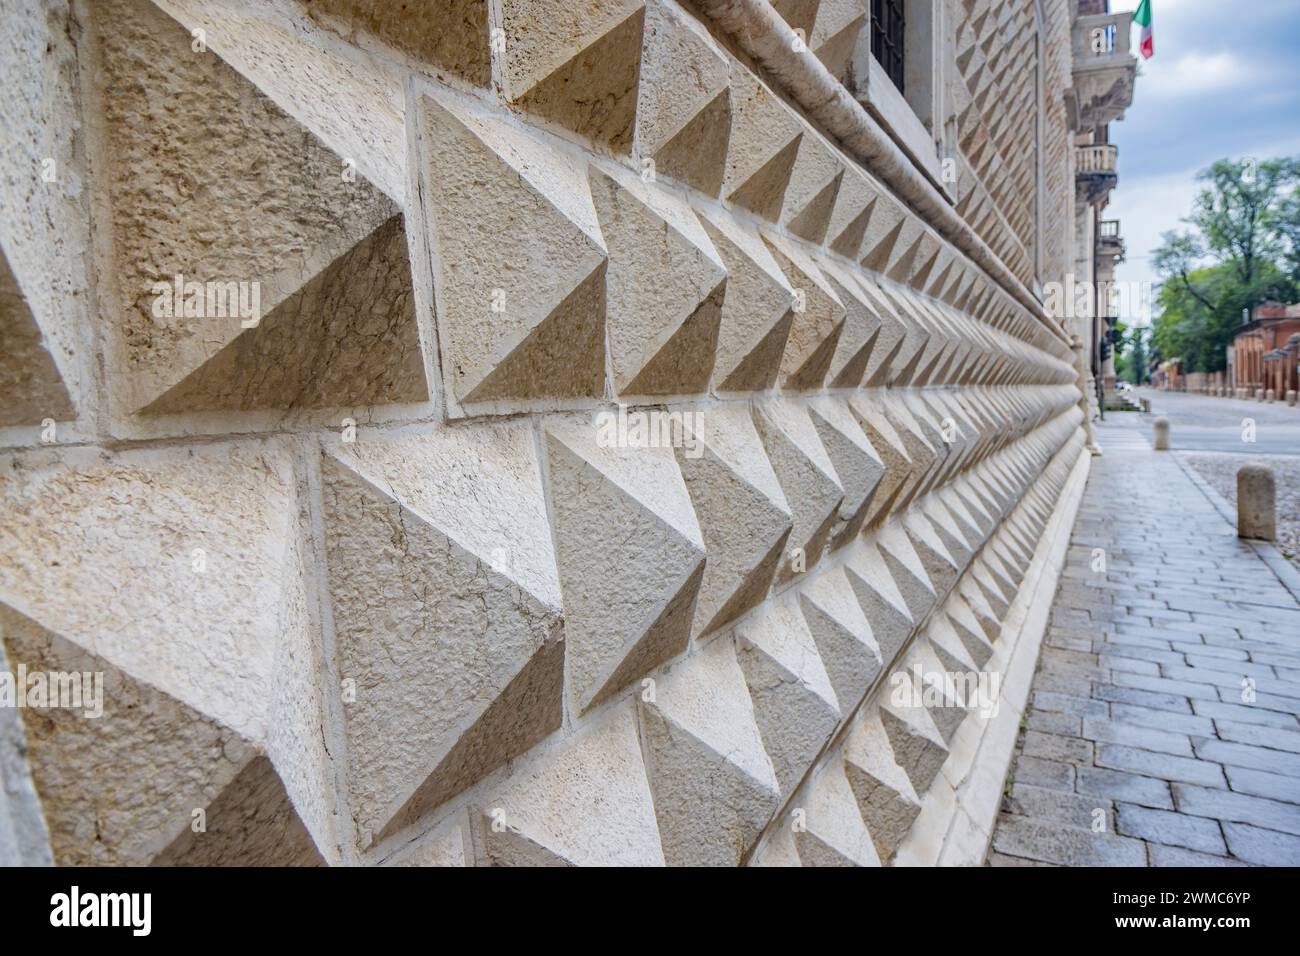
989 416 1300 866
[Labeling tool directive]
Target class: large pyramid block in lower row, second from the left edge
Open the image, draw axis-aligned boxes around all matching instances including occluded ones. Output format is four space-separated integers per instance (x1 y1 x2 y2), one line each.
321 425 564 847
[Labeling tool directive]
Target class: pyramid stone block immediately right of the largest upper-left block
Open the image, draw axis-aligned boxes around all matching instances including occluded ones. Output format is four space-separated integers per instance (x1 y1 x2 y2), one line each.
421 96 606 406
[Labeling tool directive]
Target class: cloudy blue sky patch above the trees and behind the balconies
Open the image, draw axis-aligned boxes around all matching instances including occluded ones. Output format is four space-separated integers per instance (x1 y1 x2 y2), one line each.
1102 0 1300 323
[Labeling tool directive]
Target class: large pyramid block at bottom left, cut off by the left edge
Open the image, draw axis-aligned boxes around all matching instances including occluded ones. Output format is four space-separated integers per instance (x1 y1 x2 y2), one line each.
0 442 337 865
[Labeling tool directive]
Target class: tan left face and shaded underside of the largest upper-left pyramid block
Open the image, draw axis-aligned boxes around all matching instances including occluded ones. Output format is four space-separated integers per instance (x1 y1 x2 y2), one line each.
94 0 429 414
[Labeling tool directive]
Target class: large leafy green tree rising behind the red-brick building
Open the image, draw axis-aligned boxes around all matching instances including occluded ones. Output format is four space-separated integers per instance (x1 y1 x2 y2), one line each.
1152 159 1300 372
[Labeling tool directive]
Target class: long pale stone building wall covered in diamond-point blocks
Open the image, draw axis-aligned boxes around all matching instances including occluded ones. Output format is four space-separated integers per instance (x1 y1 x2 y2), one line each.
0 0 1118 866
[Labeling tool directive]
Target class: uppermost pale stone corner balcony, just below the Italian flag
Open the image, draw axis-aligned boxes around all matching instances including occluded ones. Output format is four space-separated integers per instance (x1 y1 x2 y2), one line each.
1073 13 1138 129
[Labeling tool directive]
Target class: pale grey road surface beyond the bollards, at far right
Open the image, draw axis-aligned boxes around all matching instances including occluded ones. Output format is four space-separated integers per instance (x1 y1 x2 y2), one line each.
1128 388 1300 455
